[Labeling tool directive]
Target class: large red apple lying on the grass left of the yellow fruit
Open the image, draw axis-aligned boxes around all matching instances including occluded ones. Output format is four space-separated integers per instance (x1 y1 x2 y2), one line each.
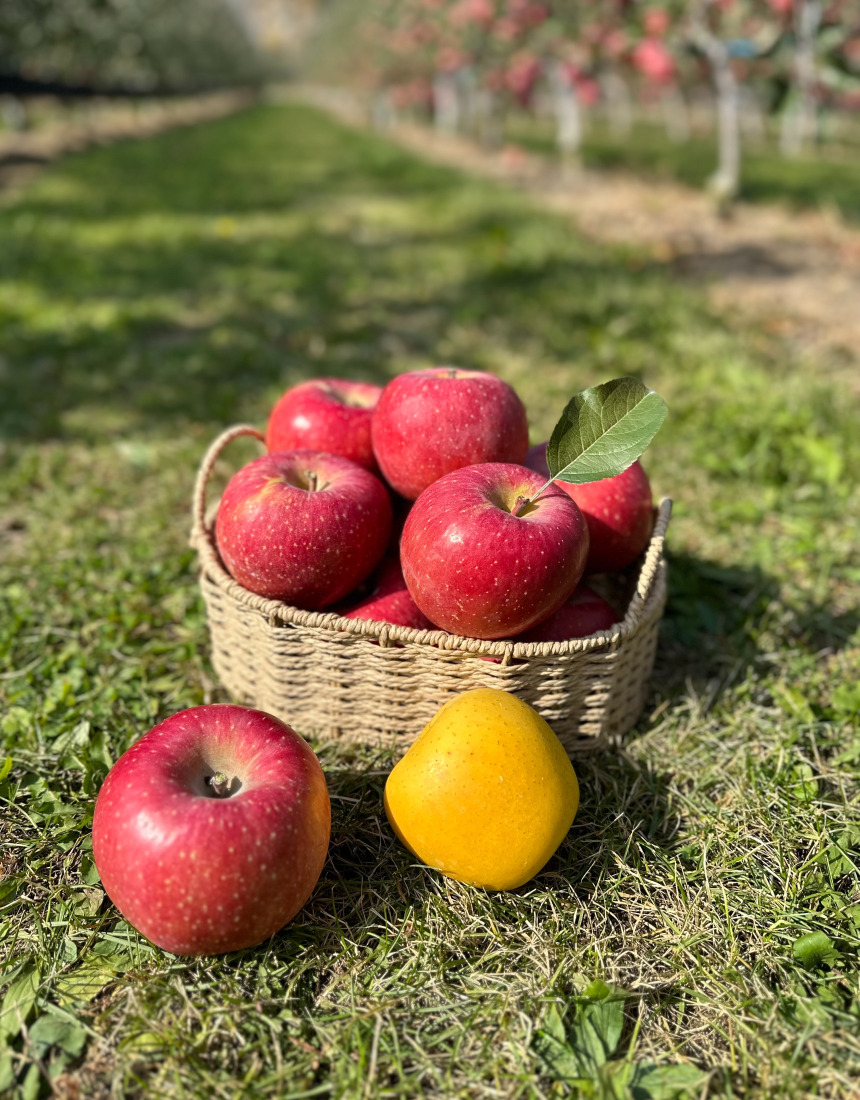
92 705 331 955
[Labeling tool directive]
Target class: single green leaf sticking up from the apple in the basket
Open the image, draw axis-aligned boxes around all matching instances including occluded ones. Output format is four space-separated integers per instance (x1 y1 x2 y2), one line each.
547 378 666 485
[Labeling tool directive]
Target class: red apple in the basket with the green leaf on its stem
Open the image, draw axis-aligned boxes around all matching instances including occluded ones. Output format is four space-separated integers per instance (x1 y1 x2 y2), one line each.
400 462 588 639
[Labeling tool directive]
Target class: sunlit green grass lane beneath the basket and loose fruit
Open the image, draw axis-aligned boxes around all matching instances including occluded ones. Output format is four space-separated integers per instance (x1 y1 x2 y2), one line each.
0 107 860 1100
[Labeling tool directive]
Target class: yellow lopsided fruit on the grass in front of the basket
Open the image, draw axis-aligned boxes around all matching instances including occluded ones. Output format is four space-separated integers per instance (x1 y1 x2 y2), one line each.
385 688 580 890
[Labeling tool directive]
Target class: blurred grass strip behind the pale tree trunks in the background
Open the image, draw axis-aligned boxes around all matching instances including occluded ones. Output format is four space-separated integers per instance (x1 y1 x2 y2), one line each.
509 119 860 222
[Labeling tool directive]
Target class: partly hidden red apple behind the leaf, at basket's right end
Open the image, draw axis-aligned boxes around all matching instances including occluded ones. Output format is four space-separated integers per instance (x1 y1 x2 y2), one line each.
526 443 654 573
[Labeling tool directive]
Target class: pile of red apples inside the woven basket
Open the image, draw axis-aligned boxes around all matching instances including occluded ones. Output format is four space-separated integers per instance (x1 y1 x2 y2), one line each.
216 367 652 641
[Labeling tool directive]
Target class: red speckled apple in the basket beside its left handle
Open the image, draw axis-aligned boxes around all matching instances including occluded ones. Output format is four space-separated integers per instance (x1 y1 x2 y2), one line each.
216 451 392 611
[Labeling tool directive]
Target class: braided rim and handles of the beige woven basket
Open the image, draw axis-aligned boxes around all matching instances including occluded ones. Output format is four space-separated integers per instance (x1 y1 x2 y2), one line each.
190 425 672 664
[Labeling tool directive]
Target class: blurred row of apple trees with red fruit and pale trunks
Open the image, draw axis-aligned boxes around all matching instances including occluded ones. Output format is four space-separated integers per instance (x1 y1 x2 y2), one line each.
351 0 860 195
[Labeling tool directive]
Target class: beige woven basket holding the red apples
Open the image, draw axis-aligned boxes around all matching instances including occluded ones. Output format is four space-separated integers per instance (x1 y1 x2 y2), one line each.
191 425 672 755
